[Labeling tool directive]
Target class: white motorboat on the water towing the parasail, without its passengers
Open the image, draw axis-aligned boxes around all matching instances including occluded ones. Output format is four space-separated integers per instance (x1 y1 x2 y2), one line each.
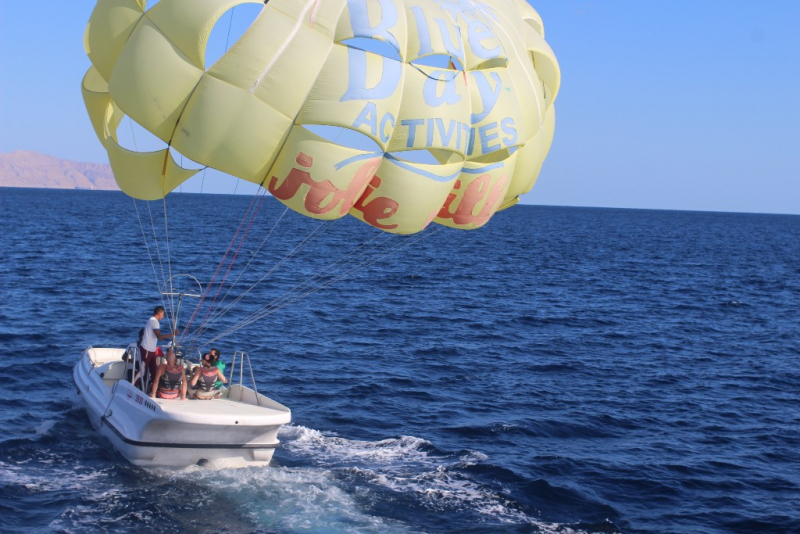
72 347 291 468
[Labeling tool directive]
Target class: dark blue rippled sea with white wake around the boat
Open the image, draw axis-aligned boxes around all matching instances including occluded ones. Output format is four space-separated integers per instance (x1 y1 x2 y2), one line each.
0 189 800 534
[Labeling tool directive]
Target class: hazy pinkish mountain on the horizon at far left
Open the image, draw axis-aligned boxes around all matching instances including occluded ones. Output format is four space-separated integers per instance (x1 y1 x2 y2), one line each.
0 150 119 191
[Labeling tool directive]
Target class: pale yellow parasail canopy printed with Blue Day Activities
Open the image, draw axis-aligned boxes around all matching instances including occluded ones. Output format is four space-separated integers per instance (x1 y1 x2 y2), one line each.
83 0 560 234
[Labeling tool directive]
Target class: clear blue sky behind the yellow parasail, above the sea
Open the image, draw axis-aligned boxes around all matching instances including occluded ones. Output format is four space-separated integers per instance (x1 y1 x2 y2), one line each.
0 0 800 214
